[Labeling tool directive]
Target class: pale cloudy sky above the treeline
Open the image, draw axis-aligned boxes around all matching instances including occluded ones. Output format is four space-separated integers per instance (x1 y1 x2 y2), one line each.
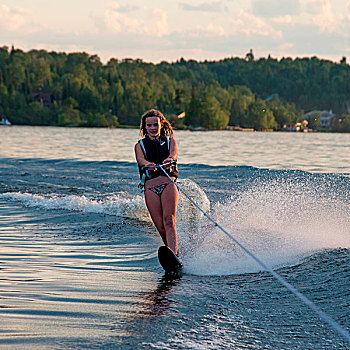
0 0 350 63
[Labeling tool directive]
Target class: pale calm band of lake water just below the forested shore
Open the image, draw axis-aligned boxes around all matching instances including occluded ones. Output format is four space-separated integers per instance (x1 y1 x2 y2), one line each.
0 126 350 173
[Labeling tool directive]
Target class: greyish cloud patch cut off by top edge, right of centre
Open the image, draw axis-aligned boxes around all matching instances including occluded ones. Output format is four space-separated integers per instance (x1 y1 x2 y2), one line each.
252 0 300 18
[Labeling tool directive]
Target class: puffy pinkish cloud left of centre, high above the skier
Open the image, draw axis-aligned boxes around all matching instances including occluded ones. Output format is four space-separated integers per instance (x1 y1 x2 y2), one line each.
104 3 169 37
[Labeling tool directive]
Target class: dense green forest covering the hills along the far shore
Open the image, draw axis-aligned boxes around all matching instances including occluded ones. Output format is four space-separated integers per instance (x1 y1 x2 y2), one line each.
0 46 350 132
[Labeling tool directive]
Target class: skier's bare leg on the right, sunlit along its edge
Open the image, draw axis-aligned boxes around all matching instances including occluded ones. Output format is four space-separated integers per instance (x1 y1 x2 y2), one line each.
160 183 179 254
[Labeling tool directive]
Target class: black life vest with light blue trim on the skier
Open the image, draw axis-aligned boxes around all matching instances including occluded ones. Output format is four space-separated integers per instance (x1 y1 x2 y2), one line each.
139 136 178 186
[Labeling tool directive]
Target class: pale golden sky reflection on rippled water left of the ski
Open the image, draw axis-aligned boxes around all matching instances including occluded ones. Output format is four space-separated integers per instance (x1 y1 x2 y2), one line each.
0 203 160 349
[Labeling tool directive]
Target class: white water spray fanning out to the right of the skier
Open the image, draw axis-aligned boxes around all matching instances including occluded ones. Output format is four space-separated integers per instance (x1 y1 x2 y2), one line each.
178 178 350 275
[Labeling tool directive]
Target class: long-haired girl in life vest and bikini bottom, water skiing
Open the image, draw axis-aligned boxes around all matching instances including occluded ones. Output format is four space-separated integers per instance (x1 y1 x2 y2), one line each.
135 109 179 255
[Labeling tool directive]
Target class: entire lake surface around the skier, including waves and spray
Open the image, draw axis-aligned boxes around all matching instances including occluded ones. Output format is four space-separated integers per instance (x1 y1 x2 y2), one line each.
0 126 350 349
